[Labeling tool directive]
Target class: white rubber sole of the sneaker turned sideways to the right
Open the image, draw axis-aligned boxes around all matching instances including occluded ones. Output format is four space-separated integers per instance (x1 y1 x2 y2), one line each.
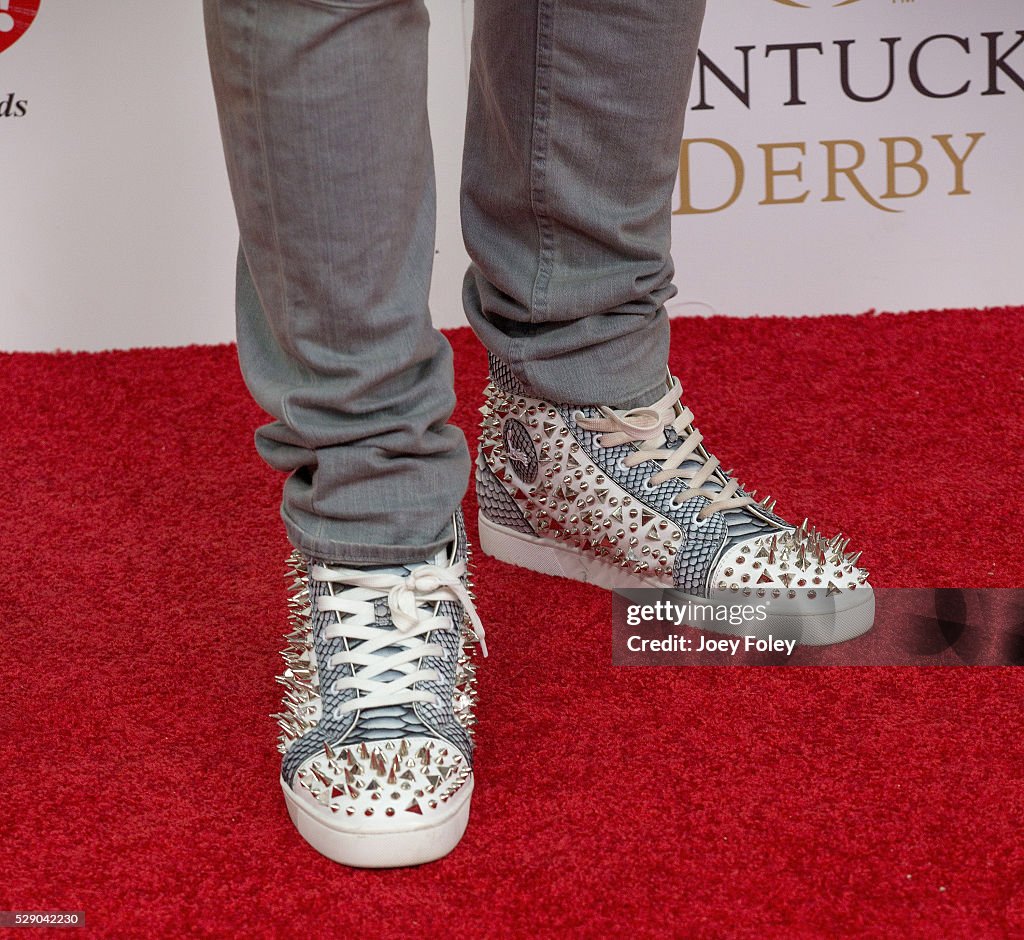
478 513 874 646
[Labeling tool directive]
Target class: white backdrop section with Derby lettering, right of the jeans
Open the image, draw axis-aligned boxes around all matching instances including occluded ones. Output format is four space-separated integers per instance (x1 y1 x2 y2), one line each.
670 0 1024 314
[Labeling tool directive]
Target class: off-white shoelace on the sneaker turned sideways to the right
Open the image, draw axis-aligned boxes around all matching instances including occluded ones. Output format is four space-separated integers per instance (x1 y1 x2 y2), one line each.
575 378 755 521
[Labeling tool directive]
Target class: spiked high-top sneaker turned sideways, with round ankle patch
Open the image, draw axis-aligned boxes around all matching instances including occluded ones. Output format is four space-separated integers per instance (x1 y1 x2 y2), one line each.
476 356 874 645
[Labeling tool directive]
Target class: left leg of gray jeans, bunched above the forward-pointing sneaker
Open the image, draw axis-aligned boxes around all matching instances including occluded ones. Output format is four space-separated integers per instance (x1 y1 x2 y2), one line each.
205 0 469 563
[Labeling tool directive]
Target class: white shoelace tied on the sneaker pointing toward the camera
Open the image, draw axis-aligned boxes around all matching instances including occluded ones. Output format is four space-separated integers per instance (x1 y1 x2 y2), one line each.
309 561 487 718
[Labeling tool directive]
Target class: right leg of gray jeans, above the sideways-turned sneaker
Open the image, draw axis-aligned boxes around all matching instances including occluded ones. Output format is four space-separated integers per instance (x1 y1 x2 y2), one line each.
462 0 705 404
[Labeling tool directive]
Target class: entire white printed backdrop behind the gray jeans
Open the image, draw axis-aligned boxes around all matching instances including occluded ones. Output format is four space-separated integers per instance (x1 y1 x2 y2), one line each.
0 0 1024 349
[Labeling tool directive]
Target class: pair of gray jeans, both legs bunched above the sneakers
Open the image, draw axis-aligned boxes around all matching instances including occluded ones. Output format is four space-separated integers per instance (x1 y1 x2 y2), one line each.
204 0 705 563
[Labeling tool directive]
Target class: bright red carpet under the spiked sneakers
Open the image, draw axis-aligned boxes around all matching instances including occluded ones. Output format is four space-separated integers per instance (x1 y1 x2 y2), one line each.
0 308 1024 940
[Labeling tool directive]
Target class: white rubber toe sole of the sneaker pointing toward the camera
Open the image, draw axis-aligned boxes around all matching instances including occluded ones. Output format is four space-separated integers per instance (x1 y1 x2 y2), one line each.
281 774 473 868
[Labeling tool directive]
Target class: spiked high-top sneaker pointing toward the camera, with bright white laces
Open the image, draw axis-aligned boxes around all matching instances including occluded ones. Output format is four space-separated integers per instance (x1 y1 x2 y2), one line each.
274 513 486 868
